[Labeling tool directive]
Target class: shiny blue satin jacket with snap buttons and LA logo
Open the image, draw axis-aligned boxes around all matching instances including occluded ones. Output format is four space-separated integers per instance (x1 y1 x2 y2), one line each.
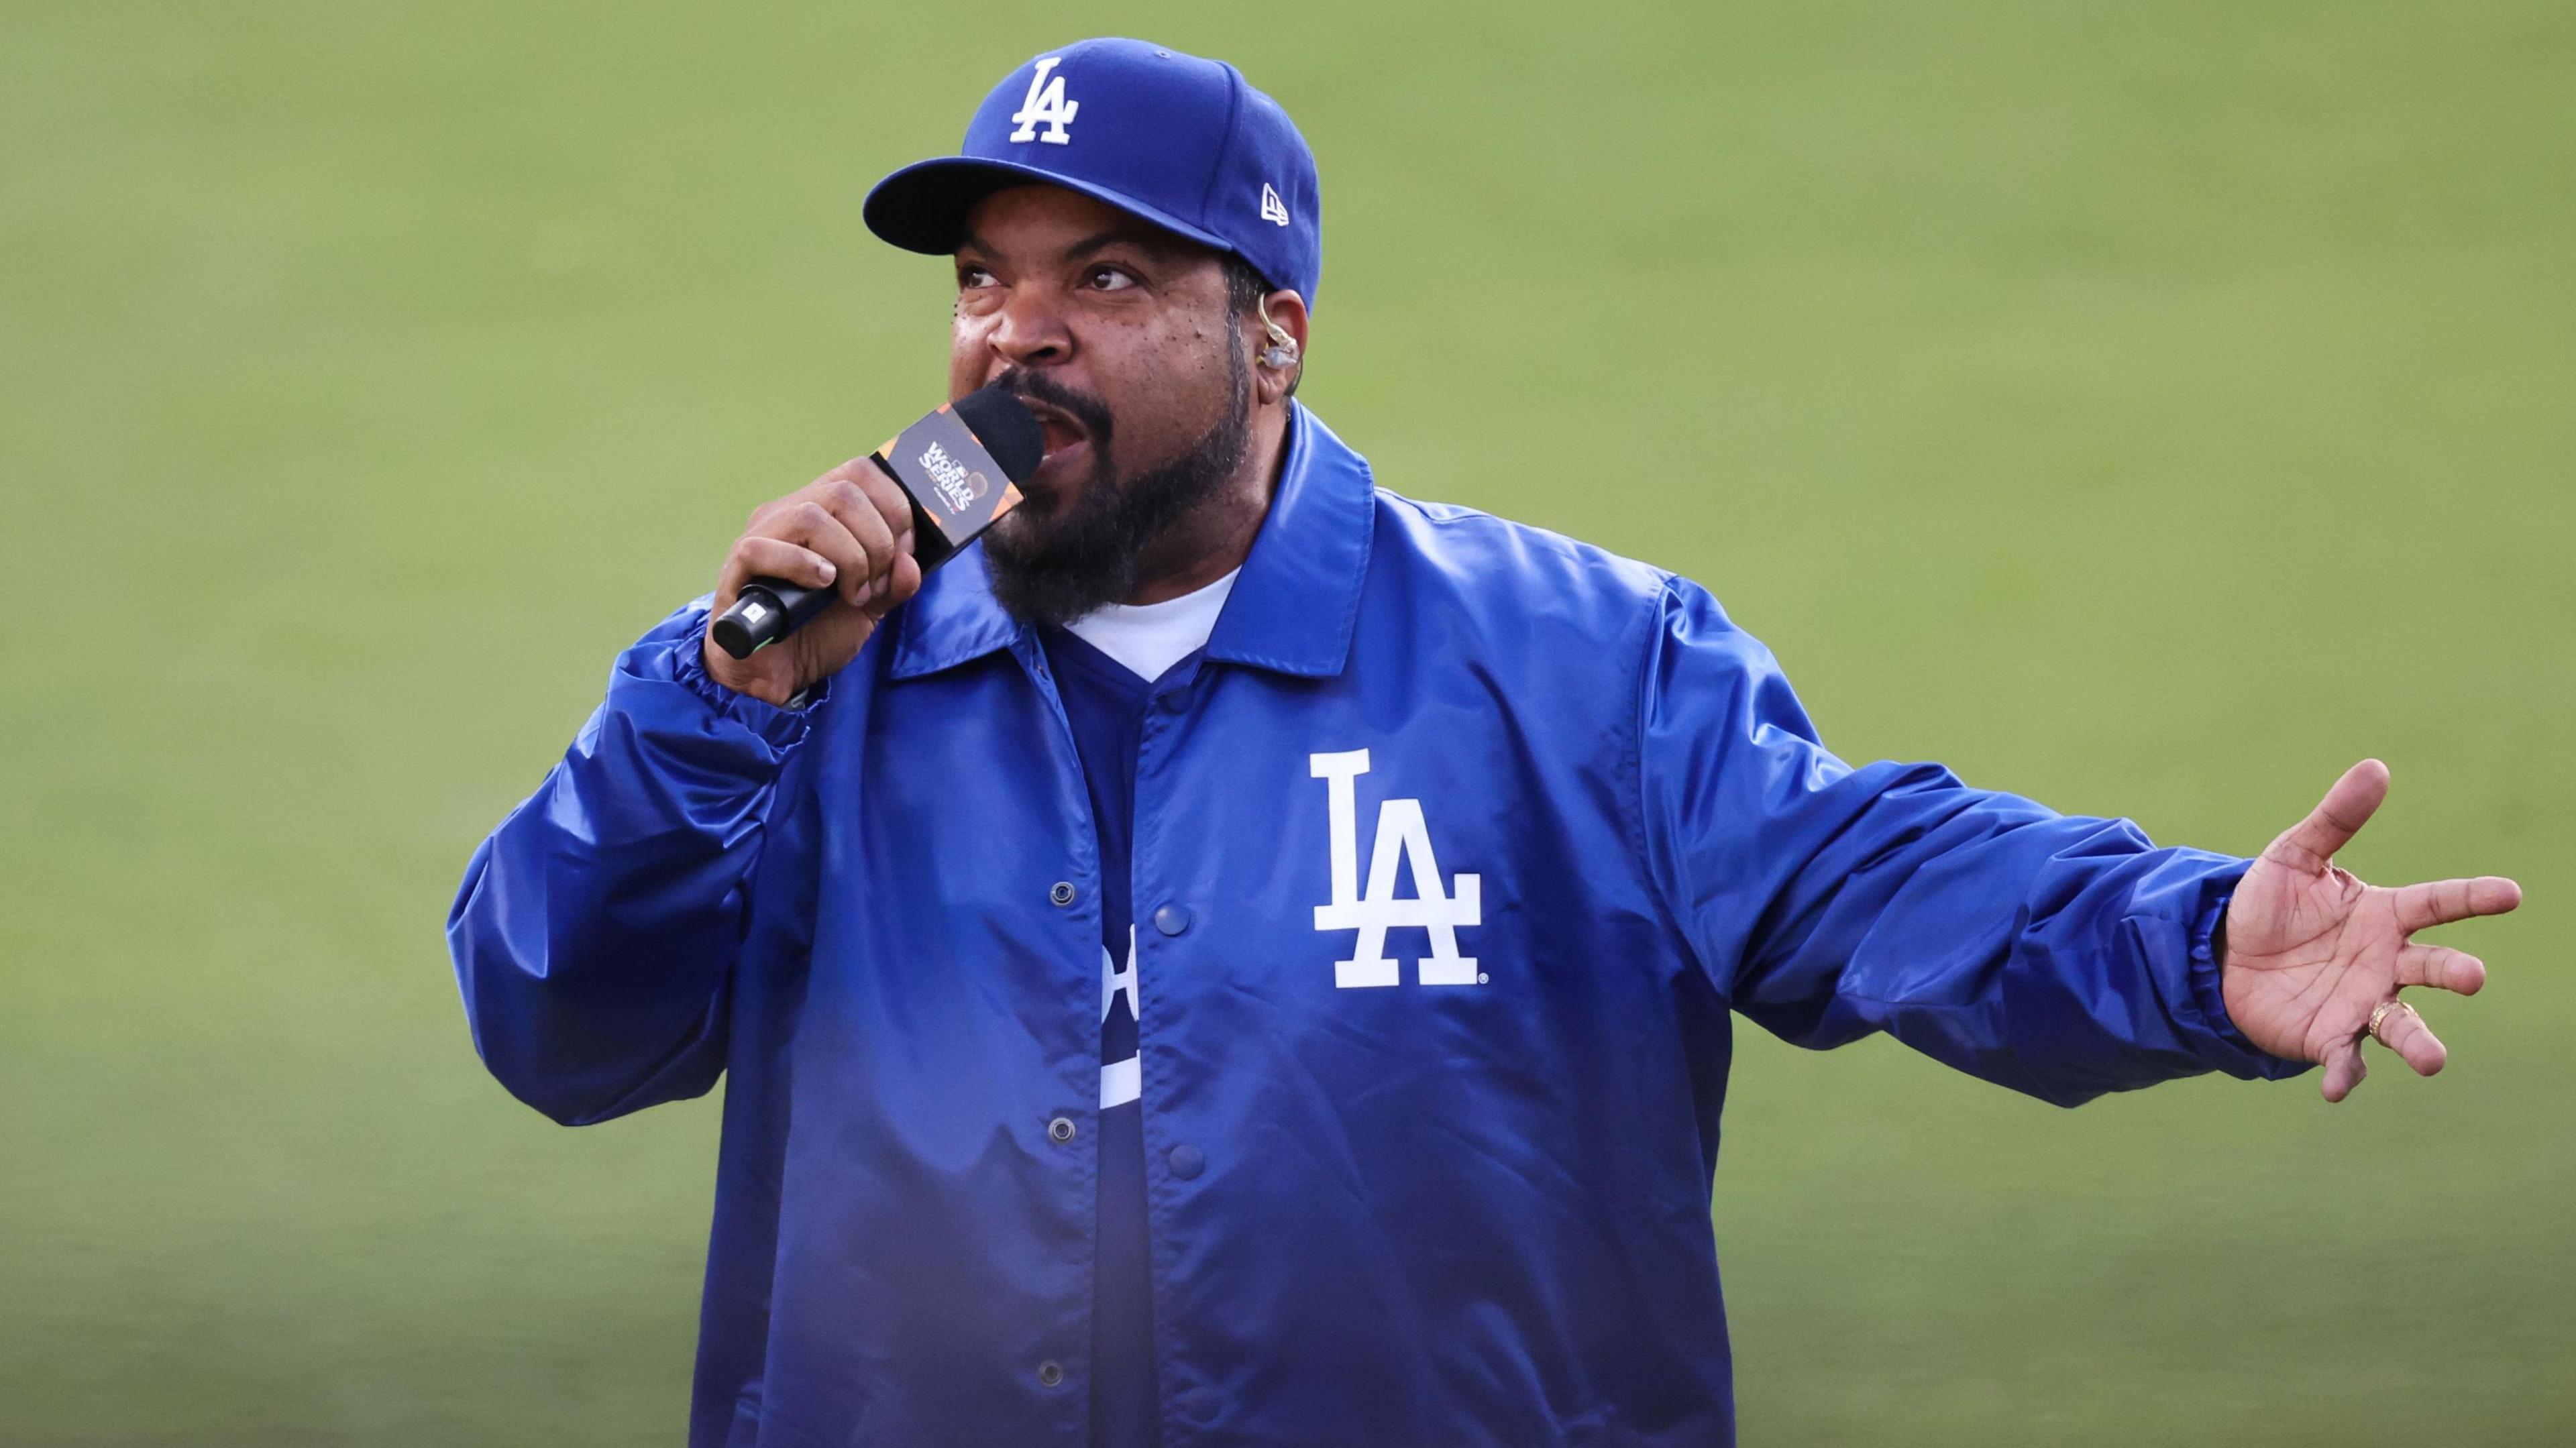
448 396 2298 1448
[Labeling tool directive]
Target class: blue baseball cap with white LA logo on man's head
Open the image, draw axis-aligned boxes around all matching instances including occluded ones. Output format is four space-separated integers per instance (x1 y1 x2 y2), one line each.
861 39 1324 307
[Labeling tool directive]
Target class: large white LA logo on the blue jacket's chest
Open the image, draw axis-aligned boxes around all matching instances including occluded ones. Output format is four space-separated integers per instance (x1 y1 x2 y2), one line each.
1306 750 1484 987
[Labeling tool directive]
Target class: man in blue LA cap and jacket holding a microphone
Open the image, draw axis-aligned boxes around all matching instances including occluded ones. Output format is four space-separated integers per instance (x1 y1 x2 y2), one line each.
448 41 2520 1448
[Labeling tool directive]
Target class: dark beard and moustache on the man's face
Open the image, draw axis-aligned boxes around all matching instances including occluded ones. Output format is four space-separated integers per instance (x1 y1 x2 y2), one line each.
984 348 1252 626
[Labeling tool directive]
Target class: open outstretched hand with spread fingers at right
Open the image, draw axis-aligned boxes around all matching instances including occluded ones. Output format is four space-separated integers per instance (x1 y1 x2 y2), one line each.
2218 760 2522 1100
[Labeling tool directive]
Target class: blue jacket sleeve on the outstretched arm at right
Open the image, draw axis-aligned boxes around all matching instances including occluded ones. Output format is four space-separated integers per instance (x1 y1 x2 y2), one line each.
1638 579 2306 1105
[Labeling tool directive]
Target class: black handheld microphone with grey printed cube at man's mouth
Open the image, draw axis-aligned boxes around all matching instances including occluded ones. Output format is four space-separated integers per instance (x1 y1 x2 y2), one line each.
711 386 1046 659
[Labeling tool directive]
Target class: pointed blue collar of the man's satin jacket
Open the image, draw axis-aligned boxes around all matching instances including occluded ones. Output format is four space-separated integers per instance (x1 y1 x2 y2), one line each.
894 402 1376 680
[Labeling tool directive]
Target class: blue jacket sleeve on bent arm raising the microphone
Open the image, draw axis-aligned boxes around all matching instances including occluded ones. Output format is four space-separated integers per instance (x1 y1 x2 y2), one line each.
448 598 822 1126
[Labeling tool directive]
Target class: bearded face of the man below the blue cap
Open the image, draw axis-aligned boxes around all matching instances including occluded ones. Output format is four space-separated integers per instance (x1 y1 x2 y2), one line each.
948 186 1252 624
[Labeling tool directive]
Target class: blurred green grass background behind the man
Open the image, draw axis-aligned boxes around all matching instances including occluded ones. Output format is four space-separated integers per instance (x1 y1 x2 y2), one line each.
0 0 2576 1445
